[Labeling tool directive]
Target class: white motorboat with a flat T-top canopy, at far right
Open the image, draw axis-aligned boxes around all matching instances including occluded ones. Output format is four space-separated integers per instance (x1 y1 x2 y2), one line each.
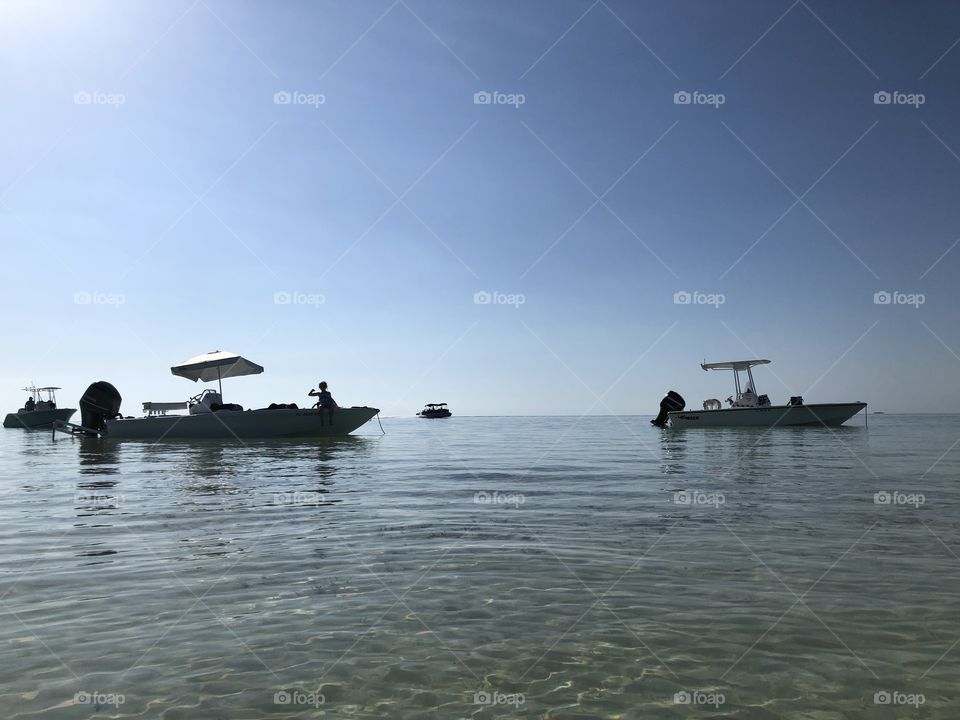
651 360 867 428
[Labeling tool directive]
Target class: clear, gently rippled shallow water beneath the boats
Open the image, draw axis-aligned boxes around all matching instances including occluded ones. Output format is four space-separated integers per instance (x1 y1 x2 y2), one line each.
0 415 960 719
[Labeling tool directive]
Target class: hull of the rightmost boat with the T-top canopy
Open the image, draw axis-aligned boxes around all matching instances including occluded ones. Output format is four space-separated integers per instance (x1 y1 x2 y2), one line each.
668 402 867 428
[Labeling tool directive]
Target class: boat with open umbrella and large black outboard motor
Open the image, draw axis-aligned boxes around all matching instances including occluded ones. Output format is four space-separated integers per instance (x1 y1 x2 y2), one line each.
73 350 380 441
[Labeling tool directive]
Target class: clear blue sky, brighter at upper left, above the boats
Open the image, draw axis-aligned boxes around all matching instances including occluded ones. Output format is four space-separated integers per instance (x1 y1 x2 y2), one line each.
0 0 960 416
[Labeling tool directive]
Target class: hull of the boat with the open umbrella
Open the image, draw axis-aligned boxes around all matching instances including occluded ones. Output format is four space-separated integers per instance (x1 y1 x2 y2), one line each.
104 407 380 441
